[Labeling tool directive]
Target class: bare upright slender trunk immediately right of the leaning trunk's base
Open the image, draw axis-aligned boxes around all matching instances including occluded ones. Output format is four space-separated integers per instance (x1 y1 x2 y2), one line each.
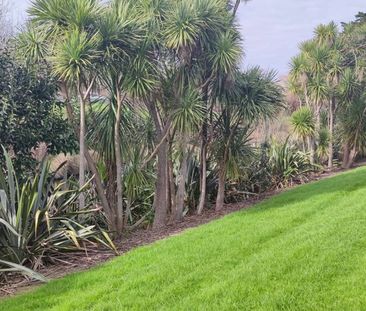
114 83 123 237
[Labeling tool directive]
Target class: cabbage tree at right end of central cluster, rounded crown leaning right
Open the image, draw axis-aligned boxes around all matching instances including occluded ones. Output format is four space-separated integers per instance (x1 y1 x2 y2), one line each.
212 67 283 210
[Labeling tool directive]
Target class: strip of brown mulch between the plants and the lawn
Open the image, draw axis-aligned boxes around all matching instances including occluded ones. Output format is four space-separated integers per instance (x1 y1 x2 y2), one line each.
0 163 365 298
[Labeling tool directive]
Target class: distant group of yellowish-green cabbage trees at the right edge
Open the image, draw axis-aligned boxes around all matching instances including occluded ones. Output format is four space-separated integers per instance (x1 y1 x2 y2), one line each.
289 13 366 168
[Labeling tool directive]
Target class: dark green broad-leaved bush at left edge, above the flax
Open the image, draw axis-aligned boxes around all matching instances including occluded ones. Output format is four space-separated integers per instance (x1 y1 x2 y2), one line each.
0 51 75 173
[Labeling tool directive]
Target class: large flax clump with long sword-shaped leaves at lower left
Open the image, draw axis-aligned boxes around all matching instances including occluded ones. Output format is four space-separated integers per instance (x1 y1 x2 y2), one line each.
0 150 115 278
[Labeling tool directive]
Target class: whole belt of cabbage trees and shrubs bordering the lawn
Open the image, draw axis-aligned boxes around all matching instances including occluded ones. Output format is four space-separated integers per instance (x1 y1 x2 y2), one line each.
0 0 366 286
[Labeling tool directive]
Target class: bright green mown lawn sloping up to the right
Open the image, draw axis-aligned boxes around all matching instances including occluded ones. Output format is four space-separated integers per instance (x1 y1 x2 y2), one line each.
0 168 366 311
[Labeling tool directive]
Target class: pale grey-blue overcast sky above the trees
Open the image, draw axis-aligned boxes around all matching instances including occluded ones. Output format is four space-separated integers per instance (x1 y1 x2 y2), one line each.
9 0 366 75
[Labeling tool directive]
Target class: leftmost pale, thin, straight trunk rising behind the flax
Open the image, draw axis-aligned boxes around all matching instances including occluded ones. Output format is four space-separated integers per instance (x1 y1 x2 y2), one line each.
78 82 86 209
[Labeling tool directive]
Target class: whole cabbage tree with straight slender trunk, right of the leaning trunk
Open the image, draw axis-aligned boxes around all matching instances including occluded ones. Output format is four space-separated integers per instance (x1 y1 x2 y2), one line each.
97 0 143 236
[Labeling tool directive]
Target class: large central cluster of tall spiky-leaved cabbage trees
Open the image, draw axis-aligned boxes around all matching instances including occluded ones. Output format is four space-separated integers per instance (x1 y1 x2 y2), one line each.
18 0 283 235
